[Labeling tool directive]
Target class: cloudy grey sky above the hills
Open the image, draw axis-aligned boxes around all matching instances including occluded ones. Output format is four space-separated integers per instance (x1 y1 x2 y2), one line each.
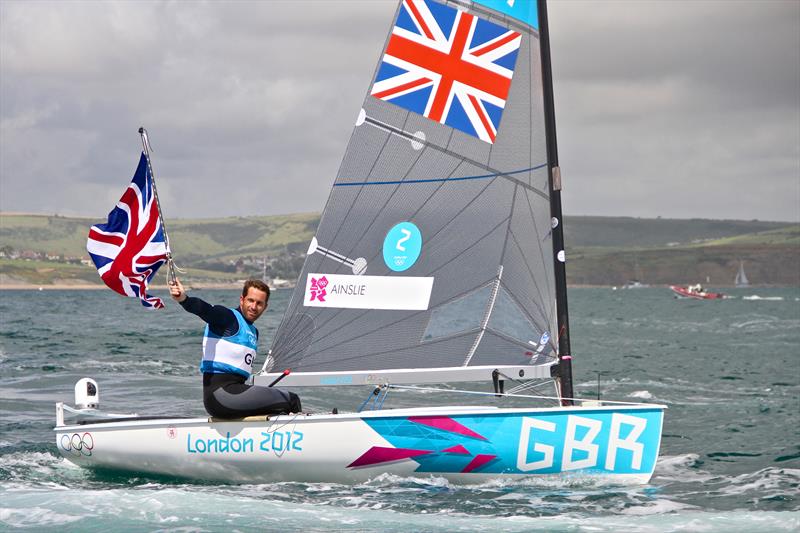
0 0 800 222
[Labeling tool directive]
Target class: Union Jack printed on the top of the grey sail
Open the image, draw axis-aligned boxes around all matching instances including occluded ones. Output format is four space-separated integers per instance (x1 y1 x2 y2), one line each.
371 0 521 143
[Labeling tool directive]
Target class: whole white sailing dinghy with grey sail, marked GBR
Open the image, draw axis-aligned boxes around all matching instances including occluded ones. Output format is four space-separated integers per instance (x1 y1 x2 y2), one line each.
55 0 665 483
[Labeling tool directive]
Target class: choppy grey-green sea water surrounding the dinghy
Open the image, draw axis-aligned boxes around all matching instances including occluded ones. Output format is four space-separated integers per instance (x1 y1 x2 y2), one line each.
0 288 800 532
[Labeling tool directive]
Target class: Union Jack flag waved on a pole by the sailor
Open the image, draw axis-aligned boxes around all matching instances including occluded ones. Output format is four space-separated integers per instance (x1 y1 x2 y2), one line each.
86 152 168 309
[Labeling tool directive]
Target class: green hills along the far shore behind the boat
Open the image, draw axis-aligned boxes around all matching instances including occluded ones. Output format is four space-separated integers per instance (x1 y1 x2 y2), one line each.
0 213 800 286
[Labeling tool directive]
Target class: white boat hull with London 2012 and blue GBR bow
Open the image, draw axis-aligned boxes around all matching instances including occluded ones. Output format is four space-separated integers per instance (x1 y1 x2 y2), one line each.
55 404 664 484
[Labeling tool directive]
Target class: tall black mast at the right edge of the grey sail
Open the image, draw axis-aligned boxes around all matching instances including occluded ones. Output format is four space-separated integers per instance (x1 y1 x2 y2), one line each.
537 0 573 405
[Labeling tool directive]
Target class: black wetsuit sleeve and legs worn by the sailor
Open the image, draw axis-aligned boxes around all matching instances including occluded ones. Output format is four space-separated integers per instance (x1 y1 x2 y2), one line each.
181 296 301 418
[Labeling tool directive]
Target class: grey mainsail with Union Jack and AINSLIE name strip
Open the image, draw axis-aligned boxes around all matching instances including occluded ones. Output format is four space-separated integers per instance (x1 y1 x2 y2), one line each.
267 0 560 384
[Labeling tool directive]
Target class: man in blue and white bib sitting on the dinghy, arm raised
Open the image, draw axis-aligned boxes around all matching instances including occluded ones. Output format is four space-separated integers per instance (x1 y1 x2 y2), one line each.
169 279 301 418
